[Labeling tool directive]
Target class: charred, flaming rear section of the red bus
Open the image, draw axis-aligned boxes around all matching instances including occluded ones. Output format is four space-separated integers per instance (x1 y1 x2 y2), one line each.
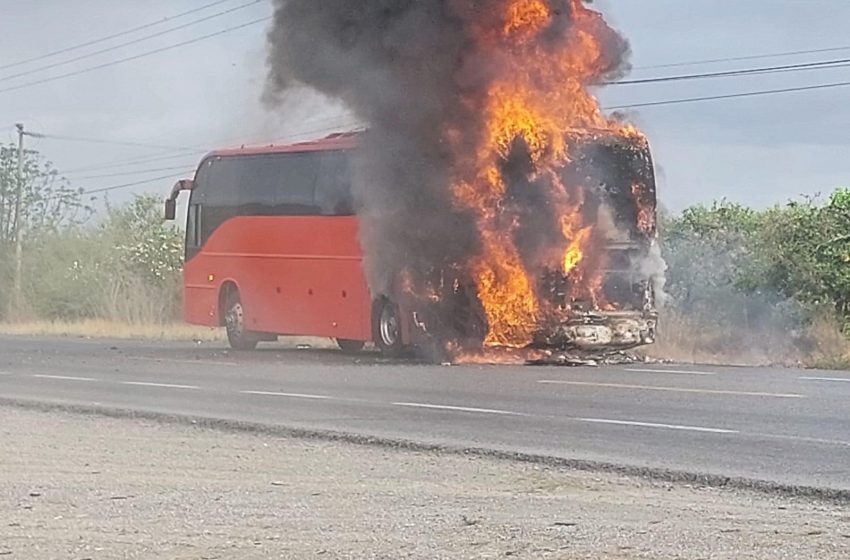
370 129 662 360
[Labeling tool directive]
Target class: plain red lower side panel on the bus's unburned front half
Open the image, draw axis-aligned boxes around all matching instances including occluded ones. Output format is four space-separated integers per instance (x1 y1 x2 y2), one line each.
186 216 371 340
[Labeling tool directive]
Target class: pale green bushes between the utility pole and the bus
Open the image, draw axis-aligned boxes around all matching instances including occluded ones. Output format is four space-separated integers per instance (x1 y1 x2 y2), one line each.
20 196 183 323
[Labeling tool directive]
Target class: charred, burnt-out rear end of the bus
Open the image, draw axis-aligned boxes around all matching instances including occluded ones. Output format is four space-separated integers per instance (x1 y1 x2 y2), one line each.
533 134 663 350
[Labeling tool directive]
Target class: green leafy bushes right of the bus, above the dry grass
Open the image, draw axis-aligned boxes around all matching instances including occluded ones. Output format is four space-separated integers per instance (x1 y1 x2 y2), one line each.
661 188 850 350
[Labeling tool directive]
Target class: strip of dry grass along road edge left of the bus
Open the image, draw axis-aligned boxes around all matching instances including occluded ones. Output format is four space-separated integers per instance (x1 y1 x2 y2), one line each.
0 319 224 342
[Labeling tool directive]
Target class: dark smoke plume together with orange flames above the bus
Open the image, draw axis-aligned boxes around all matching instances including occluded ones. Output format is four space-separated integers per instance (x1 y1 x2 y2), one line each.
264 0 636 354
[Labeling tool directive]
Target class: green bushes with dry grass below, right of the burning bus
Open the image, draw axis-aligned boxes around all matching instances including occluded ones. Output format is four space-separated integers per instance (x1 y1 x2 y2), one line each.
652 188 850 367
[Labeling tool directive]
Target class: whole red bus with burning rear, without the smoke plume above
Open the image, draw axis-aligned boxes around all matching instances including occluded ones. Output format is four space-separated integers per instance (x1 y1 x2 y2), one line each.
166 130 657 361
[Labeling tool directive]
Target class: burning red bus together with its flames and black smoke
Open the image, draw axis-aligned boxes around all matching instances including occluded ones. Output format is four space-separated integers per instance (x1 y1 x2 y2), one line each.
164 0 661 360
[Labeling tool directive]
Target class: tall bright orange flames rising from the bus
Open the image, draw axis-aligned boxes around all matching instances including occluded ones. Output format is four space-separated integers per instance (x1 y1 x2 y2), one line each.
447 0 639 347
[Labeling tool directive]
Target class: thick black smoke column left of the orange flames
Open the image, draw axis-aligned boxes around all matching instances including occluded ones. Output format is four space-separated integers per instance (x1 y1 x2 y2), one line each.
267 0 480 293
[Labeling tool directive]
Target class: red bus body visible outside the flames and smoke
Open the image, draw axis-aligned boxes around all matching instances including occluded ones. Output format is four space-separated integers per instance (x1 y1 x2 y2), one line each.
166 134 656 356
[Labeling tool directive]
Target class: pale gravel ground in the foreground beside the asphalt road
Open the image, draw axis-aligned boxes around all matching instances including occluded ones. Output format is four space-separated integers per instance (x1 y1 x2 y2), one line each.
0 407 850 560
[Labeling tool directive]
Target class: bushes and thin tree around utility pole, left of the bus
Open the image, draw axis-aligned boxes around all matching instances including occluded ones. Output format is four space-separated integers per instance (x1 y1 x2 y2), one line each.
0 146 185 334
